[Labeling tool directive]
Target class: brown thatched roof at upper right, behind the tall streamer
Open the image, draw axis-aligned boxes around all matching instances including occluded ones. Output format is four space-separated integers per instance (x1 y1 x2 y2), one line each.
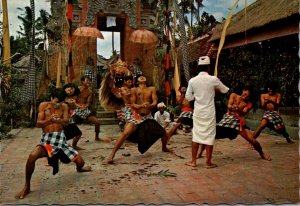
209 0 299 41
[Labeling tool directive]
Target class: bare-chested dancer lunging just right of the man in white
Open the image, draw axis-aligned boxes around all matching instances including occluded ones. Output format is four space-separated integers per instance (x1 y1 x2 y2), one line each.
198 86 271 161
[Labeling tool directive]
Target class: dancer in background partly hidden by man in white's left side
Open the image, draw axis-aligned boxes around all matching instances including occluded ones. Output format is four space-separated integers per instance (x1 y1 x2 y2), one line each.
167 85 193 139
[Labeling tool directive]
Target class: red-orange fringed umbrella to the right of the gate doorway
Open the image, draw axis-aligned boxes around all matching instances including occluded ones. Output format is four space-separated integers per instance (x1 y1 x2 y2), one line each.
129 29 157 44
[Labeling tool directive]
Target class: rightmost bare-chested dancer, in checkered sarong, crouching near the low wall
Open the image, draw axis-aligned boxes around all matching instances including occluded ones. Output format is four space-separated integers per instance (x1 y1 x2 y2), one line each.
254 82 293 143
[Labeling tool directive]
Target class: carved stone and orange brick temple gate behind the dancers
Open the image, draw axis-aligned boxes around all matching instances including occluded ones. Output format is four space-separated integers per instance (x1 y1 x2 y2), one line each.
49 0 156 83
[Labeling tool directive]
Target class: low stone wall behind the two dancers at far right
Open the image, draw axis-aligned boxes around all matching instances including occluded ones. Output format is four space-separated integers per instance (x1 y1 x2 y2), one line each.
245 107 299 139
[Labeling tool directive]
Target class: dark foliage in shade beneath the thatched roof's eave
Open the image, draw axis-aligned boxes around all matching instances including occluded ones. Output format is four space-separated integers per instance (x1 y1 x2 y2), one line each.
218 35 299 107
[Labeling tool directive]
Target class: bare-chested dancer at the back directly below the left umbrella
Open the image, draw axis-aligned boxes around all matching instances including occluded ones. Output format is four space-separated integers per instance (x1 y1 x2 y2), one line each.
74 76 100 141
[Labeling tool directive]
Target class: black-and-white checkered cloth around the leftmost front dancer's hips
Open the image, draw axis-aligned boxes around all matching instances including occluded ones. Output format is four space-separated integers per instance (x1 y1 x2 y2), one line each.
40 131 78 161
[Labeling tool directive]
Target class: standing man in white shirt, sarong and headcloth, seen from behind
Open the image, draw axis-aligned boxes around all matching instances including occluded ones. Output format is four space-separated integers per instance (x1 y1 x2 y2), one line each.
185 56 229 168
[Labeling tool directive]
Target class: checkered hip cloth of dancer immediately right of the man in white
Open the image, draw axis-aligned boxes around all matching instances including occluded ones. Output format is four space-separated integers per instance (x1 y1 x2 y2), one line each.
217 113 244 131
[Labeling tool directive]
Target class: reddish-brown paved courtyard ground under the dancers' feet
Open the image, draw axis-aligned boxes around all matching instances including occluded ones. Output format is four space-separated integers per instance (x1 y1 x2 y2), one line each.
0 125 299 205
